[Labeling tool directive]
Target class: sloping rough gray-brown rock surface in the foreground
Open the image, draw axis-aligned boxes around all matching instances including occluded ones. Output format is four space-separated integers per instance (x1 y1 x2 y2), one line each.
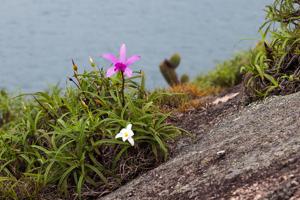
101 93 300 200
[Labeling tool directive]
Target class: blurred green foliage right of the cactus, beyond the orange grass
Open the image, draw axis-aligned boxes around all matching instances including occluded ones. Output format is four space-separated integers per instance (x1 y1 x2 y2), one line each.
194 50 252 88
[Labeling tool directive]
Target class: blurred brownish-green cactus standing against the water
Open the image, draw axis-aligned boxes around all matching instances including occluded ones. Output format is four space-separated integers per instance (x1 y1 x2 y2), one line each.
159 53 189 86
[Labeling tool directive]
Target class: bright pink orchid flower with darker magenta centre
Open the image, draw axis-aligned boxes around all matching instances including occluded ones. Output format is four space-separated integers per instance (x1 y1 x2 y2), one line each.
102 44 141 77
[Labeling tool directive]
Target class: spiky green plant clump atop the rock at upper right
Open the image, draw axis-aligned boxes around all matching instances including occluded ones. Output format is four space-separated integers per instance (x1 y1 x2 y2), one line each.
243 0 300 100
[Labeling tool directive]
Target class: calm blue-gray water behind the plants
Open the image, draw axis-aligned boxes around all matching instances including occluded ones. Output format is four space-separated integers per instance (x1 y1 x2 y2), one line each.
0 0 272 91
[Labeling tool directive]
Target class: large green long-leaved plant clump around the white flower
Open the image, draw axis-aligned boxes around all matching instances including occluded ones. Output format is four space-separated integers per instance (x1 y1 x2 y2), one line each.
0 64 182 199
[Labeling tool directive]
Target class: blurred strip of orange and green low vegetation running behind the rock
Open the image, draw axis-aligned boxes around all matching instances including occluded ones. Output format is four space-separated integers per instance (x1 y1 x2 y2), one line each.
154 49 256 112
